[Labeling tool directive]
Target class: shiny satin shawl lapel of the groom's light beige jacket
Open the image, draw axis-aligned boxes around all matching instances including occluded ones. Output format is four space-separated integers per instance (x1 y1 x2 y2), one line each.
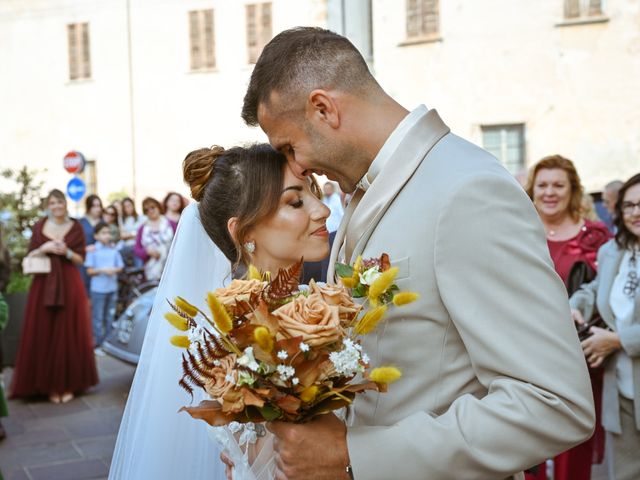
338 110 449 263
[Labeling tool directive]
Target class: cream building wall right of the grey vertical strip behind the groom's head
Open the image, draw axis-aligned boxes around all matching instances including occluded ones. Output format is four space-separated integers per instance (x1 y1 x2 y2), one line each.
373 0 640 191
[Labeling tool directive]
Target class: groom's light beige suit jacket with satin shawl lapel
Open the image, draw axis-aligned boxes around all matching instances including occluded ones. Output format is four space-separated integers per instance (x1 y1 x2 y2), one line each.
329 107 594 480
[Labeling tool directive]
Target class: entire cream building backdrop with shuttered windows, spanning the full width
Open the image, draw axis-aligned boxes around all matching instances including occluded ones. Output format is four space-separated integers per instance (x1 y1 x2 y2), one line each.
0 0 640 206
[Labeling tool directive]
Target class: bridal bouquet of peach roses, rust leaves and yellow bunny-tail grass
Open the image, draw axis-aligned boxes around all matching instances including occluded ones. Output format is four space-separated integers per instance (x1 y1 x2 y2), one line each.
165 255 417 426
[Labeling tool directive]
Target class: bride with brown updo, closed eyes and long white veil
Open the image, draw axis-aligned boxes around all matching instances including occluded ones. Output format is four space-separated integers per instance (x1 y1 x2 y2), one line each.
109 145 330 480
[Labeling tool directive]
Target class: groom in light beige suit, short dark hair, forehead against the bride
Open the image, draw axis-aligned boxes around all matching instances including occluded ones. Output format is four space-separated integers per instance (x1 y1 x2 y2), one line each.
242 28 594 480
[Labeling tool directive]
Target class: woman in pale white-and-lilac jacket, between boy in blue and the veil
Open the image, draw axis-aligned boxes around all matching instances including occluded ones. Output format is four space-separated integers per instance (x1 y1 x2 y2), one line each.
134 197 174 280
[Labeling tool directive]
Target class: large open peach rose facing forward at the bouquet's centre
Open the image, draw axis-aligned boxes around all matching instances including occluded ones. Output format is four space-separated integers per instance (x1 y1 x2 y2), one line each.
273 293 344 346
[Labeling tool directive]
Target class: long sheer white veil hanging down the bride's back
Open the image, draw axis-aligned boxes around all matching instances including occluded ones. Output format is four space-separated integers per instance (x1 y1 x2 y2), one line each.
109 203 231 480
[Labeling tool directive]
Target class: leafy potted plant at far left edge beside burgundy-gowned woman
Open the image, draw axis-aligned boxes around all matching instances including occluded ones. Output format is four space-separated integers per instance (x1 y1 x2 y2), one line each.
0 166 43 365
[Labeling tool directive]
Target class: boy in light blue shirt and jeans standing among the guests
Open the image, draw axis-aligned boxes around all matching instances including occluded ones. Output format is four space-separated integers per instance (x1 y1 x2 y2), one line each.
84 222 124 348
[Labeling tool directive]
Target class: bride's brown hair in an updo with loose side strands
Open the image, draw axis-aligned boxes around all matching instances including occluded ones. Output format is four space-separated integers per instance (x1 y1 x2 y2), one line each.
182 144 287 267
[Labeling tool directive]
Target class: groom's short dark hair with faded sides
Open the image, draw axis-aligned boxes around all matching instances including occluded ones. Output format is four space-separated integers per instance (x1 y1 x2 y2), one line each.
242 27 378 126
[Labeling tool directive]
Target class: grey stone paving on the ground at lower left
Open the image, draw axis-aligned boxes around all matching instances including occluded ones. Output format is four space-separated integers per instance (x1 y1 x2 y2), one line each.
0 356 607 480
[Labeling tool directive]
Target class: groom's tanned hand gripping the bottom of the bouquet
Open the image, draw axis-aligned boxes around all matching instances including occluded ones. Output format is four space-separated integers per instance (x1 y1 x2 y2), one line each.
267 413 349 480
